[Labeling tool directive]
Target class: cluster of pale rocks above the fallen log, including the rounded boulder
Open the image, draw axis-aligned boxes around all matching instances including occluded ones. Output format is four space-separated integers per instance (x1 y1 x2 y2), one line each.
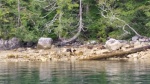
105 36 150 51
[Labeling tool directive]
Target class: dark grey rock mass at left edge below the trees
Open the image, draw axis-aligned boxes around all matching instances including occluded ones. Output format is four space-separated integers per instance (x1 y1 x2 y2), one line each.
0 37 20 50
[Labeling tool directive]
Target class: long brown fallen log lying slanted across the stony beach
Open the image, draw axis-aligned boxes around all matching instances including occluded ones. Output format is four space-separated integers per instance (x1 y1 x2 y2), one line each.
80 45 150 60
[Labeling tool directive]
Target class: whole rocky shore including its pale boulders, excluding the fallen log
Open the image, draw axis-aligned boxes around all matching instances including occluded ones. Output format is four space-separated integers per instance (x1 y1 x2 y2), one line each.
0 36 150 62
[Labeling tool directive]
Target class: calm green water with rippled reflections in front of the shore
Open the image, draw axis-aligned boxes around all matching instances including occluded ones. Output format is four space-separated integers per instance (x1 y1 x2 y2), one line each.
0 61 150 84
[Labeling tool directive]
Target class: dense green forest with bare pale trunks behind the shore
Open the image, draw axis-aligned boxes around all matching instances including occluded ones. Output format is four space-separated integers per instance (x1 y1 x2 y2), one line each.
0 0 150 42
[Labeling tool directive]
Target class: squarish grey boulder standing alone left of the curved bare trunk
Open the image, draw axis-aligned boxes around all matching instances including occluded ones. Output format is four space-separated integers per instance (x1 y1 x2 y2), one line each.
37 37 53 49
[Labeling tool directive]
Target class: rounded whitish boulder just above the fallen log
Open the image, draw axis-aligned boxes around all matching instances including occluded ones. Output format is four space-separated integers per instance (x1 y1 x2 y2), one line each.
105 38 123 50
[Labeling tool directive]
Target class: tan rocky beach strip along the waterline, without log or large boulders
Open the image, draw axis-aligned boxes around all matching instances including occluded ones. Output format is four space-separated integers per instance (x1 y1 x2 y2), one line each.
0 44 150 62
